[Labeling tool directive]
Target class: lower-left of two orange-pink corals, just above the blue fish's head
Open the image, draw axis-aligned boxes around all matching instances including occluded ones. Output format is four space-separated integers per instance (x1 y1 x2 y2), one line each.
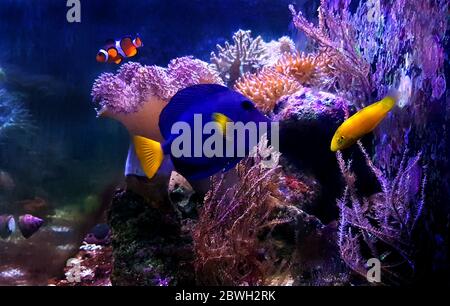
234 68 301 113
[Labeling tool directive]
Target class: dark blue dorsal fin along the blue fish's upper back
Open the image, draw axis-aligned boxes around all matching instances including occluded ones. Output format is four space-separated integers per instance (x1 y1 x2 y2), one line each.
159 84 229 139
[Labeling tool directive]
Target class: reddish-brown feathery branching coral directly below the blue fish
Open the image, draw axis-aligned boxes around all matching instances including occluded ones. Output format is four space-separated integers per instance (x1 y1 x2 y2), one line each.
193 145 296 285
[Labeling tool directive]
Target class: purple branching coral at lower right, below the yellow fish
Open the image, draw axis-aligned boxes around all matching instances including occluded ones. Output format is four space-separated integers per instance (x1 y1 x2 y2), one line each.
337 142 426 284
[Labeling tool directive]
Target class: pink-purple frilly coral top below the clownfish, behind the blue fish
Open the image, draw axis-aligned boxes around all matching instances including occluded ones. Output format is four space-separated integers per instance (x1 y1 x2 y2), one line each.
92 57 222 113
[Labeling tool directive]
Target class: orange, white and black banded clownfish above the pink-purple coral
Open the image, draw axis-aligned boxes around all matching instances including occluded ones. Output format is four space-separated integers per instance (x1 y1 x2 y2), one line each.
96 35 144 64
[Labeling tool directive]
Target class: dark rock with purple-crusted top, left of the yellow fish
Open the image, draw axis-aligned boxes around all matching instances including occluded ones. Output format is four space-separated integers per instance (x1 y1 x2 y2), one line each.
273 88 348 222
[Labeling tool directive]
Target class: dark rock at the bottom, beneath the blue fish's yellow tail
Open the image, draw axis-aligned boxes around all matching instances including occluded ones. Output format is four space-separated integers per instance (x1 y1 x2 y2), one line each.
108 176 194 286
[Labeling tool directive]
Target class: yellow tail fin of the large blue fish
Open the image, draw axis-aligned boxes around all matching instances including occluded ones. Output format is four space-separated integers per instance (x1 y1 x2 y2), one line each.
133 136 164 179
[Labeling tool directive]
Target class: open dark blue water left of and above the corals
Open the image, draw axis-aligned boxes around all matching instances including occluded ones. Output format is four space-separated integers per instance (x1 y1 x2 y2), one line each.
0 0 317 285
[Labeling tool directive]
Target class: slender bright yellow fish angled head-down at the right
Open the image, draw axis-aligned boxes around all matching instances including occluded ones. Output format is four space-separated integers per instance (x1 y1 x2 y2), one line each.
330 92 398 152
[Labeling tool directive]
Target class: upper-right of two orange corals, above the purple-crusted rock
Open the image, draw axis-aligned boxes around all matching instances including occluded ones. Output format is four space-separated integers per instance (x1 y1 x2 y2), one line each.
275 52 329 86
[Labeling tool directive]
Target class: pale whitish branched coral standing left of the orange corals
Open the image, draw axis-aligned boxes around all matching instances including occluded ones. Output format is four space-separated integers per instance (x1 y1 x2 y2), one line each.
211 30 267 86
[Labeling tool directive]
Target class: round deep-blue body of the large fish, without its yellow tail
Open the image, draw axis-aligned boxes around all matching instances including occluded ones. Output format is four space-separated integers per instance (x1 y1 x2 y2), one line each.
159 84 270 180
